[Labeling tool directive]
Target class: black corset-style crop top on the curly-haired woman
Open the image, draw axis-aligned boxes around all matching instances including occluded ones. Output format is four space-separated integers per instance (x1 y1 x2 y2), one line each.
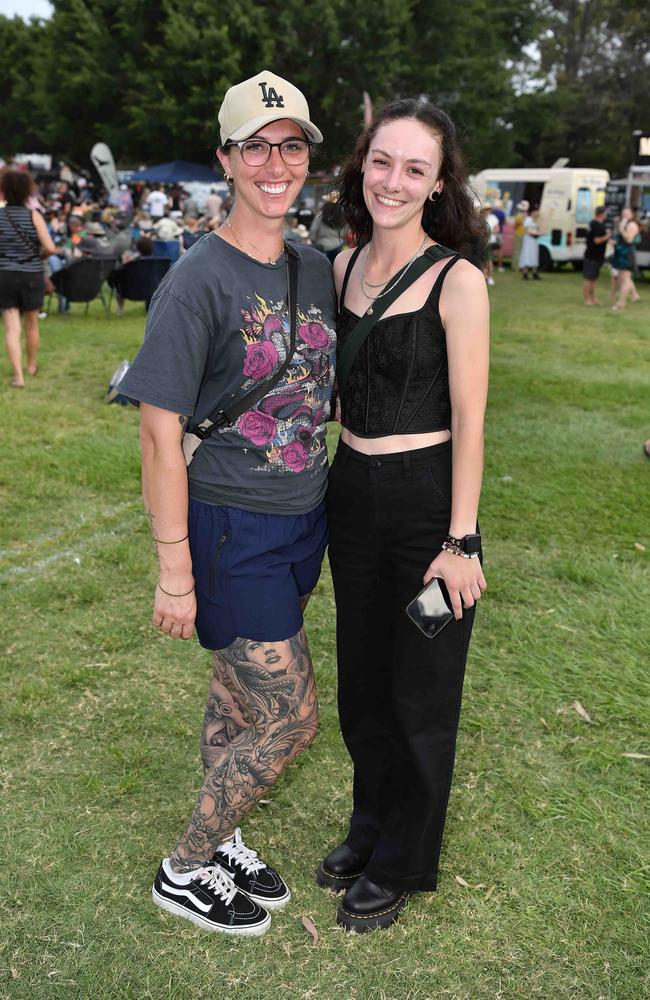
336 244 460 438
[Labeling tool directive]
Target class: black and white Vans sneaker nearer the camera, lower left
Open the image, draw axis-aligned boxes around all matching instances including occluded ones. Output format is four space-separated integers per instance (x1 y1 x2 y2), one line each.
151 858 271 937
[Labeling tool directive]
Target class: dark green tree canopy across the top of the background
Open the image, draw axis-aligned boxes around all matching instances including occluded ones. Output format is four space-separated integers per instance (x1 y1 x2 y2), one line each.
0 0 650 173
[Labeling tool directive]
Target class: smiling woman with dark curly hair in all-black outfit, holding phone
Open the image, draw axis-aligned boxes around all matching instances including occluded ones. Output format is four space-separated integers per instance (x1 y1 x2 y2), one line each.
318 98 489 932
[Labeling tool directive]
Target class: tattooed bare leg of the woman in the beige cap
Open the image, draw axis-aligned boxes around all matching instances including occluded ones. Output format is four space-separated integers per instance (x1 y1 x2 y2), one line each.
171 629 318 871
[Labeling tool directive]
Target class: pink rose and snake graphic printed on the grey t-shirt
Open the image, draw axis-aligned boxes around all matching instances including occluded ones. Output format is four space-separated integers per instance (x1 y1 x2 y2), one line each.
235 295 335 473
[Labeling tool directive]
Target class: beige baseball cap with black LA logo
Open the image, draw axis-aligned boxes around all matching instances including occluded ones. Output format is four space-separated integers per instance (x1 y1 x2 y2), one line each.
219 70 323 145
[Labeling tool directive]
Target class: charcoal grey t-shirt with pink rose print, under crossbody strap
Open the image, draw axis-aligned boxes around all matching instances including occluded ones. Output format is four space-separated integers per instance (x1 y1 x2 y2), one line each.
120 233 336 514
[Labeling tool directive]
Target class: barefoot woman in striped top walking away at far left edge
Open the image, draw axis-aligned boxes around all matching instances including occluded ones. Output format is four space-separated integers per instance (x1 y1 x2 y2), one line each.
0 167 57 389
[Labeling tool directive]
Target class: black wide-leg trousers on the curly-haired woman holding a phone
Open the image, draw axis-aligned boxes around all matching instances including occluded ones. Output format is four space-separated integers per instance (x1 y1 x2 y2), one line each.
327 441 474 892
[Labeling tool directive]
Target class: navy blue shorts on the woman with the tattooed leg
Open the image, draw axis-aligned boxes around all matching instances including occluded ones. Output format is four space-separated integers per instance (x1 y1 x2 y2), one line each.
189 498 327 649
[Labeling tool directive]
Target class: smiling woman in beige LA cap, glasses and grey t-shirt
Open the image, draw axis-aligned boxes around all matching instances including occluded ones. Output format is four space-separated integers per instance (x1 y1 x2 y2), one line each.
121 72 336 935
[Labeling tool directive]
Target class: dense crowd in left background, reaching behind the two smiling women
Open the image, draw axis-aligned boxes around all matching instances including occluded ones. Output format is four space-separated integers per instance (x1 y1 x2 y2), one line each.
0 162 350 388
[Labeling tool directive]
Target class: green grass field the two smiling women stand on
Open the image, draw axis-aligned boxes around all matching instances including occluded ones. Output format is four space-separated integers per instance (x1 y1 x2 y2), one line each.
0 273 650 1000
